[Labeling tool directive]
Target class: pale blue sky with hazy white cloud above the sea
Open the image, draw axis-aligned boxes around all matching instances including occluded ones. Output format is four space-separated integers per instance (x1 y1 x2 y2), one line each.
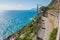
0 0 51 10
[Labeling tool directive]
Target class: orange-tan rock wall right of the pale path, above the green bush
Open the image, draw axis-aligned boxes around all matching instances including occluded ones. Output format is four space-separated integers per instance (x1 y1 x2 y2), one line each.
47 10 59 28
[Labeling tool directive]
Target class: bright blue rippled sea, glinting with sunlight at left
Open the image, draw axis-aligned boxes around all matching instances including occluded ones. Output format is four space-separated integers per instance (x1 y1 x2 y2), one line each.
0 10 37 40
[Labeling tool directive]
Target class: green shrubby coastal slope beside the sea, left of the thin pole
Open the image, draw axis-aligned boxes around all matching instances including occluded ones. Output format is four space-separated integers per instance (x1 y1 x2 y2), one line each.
5 16 41 40
